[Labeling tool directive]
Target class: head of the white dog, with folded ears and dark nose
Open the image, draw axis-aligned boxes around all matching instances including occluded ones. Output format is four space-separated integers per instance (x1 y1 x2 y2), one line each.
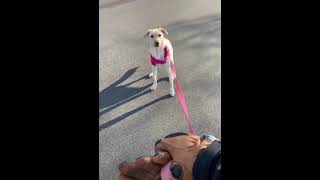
145 28 168 47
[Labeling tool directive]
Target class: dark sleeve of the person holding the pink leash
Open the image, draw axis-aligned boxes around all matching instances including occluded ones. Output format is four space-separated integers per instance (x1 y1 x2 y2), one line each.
192 141 221 180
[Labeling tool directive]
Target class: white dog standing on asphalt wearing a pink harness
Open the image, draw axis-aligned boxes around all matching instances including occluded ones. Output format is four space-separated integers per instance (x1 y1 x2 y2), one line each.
145 28 175 96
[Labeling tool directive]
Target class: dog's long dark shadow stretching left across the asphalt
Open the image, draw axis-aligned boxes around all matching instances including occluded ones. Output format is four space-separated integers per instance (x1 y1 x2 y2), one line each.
99 67 169 129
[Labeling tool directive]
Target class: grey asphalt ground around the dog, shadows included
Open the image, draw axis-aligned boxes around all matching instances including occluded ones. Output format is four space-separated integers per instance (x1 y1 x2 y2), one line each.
99 0 221 180
